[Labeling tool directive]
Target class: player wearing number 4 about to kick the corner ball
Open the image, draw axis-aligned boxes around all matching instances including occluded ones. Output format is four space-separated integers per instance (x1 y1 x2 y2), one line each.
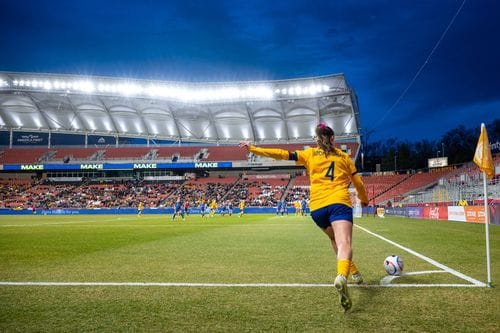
240 123 368 311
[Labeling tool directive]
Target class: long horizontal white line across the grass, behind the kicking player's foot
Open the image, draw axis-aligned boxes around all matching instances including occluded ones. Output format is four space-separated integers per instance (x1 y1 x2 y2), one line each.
0 281 482 288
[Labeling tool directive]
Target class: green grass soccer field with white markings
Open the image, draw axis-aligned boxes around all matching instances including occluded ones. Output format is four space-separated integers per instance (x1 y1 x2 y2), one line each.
0 215 500 332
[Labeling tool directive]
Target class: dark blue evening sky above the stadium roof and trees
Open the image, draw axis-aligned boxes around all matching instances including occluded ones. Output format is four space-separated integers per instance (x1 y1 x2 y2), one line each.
0 0 500 141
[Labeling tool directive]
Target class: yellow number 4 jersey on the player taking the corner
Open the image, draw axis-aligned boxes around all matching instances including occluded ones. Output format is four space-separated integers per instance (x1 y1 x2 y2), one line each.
249 146 368 211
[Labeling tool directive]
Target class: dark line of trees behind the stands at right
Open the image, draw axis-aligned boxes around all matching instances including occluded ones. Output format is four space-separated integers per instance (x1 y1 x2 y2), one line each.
357 119 500 172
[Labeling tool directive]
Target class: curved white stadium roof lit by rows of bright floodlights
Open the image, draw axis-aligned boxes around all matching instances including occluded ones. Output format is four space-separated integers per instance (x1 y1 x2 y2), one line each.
0 72 360 143
